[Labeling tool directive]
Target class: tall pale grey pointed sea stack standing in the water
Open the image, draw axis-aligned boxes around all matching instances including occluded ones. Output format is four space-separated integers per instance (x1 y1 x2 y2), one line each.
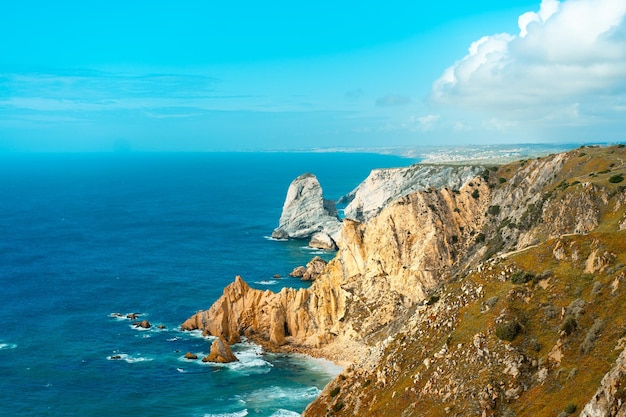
272 174 341 244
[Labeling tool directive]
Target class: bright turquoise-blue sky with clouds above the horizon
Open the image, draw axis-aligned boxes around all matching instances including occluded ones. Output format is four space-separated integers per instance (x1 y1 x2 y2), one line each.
0 0 626 152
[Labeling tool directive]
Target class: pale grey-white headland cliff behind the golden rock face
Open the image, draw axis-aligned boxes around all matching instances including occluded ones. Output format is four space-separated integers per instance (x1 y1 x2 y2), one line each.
339 164 485 222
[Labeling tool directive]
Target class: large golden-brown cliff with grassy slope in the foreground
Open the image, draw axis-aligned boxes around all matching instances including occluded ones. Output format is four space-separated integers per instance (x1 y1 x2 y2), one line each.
183 146 626 417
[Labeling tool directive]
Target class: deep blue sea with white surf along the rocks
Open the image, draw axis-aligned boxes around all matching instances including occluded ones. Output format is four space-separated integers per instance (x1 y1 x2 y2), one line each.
0 153 412 416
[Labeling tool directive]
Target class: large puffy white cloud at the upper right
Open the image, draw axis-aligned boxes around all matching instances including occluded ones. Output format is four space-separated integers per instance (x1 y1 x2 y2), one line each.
431 0 626 128
